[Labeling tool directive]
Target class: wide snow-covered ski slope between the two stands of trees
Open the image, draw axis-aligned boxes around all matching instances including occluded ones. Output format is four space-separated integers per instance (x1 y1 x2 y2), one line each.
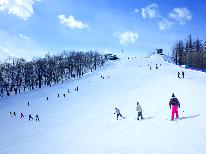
0 55 206 154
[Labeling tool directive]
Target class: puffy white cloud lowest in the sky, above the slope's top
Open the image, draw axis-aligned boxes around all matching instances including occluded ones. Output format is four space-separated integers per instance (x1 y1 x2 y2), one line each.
114 31 139 45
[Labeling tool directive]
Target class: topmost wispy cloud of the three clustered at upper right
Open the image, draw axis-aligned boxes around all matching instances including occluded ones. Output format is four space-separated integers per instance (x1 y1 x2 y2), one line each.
142 3 159 18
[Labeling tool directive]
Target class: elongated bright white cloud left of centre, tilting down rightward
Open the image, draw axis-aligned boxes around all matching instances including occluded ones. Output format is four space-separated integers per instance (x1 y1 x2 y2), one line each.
58 15 88 29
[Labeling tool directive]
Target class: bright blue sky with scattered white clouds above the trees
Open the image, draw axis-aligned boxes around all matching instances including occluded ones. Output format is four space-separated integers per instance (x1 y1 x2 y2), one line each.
0 0 206 59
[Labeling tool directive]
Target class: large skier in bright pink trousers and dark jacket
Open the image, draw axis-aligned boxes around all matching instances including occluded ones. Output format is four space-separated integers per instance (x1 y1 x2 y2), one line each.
169 93 180 120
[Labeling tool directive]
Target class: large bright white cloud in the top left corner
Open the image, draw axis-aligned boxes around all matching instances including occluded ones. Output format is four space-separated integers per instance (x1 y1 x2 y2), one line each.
0 0 41 20
